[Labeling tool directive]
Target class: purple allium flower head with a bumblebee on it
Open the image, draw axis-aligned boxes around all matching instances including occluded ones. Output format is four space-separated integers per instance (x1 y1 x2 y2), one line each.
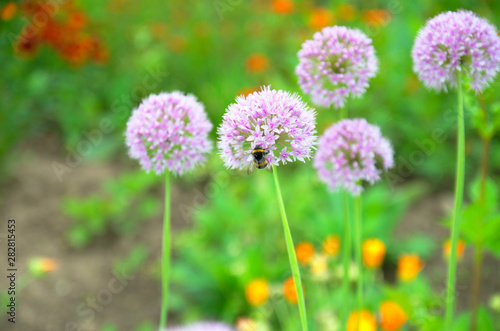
217 87 316 169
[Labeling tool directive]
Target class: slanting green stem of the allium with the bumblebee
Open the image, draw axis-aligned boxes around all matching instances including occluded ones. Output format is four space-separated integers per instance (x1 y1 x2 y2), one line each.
273 166 307 331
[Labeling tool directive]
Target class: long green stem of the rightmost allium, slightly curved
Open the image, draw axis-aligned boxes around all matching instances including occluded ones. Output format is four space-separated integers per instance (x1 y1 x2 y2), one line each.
445 71 465 331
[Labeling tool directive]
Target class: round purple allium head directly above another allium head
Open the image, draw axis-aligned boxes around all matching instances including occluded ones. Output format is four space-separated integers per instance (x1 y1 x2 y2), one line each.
295 26 378 108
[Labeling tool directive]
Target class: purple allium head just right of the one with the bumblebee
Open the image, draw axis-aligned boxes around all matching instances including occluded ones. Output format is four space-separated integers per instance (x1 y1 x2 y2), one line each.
314 118 394 195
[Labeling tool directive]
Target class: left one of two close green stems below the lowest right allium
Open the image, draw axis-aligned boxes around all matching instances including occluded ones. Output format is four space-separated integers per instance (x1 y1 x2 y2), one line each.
342 191 352 329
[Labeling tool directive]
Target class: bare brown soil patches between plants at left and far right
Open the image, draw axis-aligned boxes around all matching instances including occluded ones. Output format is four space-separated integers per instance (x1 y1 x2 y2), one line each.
0 139 500 331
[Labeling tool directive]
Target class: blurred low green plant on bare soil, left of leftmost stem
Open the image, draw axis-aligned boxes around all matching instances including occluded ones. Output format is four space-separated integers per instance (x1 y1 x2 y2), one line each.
61 171 160 248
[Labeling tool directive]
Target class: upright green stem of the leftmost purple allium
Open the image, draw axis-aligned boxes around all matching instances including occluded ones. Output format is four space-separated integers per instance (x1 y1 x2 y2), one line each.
160 171 171 330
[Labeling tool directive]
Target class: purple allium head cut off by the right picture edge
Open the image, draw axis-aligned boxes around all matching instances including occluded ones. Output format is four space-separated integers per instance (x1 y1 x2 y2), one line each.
412 10 500 92
